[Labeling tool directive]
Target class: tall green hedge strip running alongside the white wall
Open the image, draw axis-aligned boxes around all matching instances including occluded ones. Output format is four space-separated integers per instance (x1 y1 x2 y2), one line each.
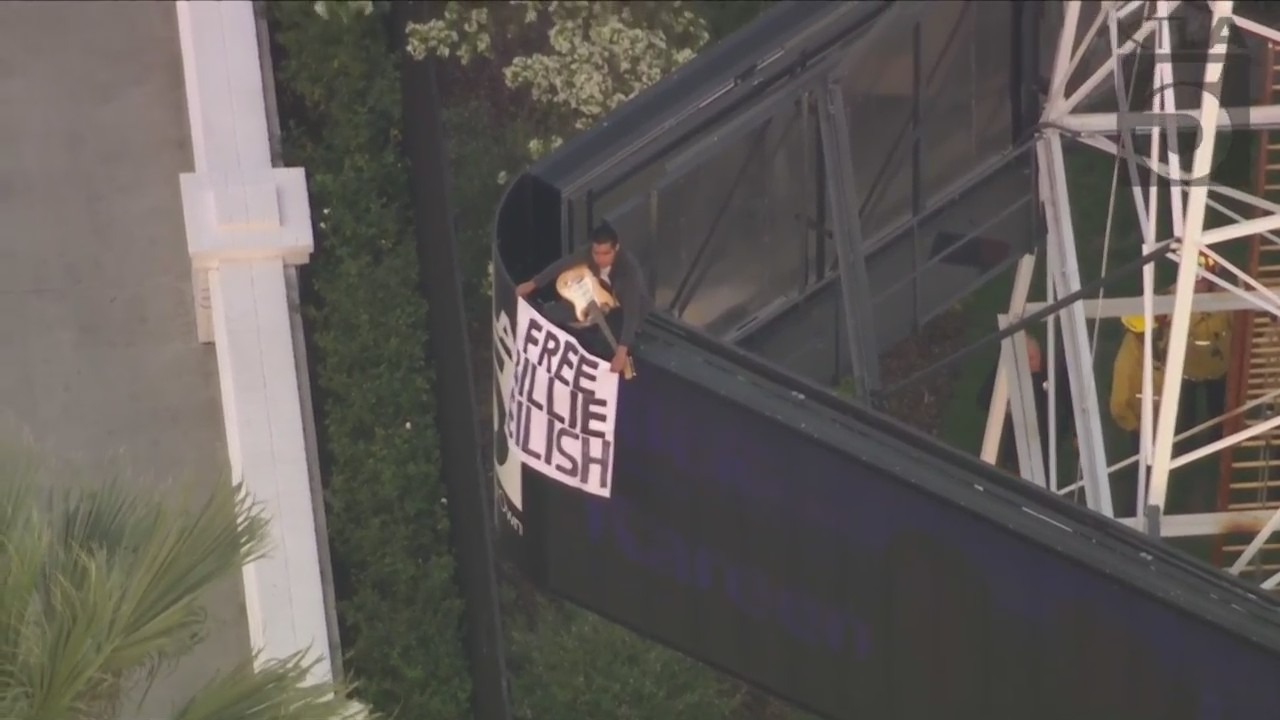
269 3 471 720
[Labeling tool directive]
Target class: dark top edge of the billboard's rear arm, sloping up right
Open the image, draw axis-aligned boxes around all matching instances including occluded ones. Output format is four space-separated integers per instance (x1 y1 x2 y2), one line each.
530 0 887 188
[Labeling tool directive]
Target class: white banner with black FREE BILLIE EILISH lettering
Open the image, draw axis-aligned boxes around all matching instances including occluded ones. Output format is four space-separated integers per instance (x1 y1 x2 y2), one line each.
503 299 618 497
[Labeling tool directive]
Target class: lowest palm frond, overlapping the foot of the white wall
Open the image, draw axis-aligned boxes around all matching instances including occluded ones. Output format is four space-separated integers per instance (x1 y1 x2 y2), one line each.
174 653 378 720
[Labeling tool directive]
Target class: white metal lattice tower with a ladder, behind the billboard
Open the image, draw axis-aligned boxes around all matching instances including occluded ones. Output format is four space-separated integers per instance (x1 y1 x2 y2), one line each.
983 0 1280 588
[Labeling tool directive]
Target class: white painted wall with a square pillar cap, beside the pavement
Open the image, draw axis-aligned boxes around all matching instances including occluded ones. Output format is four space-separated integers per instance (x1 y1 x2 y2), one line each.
175 0 333 682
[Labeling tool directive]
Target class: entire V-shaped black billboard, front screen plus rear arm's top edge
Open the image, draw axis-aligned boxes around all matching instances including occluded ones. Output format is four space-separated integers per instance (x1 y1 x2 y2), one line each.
483 3 1280 707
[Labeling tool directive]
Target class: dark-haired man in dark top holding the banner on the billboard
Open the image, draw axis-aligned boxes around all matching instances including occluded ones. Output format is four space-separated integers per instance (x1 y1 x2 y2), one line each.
516 223 653 373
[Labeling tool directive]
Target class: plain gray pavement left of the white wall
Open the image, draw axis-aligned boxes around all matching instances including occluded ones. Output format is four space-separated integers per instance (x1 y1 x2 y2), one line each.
0 3 248 719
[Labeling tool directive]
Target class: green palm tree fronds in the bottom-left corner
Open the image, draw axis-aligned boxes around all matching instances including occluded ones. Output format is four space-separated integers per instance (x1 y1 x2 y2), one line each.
0 447 365 720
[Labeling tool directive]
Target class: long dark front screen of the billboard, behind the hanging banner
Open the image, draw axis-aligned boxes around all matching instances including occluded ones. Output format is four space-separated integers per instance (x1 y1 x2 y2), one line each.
494 242 1280 720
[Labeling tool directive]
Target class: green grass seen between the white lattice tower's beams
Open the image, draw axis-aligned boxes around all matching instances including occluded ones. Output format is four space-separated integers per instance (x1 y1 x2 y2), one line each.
940 127 1252 553
